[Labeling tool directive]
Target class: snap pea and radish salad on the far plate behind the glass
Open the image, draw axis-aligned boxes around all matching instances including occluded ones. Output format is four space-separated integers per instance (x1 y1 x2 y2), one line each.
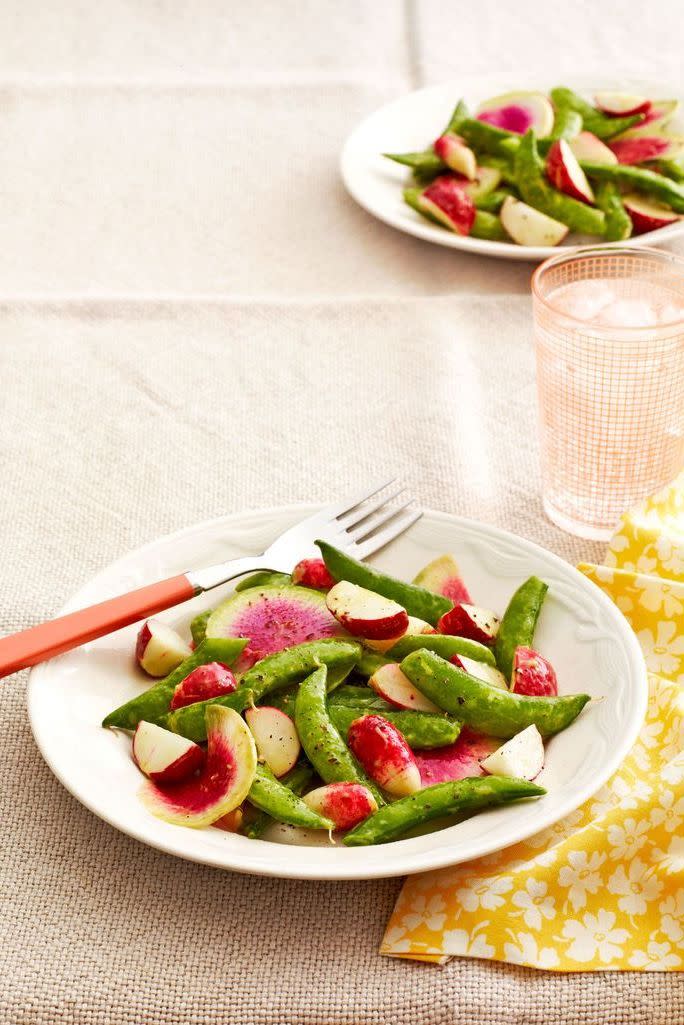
385 86 684 246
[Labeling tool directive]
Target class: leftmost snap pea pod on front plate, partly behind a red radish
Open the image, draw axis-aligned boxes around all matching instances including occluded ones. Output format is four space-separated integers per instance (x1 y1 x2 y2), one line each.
103 638 247 736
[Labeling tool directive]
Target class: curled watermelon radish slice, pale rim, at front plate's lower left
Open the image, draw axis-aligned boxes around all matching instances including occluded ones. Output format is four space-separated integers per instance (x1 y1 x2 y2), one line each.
140 705 256 829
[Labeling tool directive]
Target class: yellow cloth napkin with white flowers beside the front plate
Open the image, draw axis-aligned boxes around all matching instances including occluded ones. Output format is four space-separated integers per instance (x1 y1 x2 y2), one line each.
380 474 684 972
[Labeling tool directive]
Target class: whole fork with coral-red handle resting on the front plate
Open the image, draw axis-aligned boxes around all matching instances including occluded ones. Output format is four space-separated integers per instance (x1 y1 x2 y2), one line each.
0 478 423 678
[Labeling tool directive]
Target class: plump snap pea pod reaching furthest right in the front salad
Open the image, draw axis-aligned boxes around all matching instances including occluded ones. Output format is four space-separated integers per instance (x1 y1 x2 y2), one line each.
401 651 590 740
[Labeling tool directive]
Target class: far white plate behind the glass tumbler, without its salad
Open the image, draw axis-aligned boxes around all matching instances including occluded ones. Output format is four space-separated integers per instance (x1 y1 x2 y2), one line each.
340 73 684 261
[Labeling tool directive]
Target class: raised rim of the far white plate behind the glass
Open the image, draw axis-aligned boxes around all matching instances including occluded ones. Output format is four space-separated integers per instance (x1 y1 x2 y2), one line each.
339 72 684 262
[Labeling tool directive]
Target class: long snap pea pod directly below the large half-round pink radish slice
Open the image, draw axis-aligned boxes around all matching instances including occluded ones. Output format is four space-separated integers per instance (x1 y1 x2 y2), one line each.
159 638 361 742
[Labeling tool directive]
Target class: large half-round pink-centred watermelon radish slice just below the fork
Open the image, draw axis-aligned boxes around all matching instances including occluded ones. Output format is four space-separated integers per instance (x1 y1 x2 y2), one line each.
206 585 347 673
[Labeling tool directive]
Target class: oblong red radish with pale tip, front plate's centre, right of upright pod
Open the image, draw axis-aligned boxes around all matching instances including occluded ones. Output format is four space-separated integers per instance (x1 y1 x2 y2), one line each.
347 715 420 797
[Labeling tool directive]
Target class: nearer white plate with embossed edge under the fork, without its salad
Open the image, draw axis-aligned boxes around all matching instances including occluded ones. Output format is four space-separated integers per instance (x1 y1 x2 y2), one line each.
29 506 647 879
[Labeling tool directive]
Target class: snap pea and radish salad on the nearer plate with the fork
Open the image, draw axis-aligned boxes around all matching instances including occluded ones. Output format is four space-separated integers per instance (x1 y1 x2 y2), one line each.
103 541 590 847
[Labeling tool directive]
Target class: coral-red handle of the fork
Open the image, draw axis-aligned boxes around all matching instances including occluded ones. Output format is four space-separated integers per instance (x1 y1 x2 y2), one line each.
0 574 196 678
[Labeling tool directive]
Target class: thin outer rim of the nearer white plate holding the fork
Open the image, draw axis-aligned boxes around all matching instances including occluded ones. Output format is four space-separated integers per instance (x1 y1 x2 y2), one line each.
27 502 648 880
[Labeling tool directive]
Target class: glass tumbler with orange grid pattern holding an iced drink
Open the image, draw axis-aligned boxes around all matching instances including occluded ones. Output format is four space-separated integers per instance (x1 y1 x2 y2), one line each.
532 247 684 540
